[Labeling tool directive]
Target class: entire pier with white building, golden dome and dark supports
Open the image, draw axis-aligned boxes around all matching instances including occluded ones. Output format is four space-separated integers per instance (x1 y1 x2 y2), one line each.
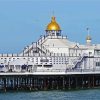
0 16 100 92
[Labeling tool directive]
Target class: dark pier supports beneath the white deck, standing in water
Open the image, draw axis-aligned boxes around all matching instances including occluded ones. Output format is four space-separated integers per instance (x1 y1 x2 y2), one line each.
0 74 100 92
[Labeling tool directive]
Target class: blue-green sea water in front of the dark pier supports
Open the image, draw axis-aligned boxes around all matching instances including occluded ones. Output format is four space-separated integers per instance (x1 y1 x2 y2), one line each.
0 89 100 100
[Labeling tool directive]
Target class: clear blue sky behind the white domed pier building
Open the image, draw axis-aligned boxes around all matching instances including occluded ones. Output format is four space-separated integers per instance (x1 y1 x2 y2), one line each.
0 0 100 53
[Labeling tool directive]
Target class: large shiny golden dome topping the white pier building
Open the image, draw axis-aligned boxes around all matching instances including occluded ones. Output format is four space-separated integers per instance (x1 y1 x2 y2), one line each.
46 16 60 31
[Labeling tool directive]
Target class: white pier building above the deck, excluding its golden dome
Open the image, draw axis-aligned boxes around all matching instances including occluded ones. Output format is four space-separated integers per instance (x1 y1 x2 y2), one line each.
0 16 100 74
